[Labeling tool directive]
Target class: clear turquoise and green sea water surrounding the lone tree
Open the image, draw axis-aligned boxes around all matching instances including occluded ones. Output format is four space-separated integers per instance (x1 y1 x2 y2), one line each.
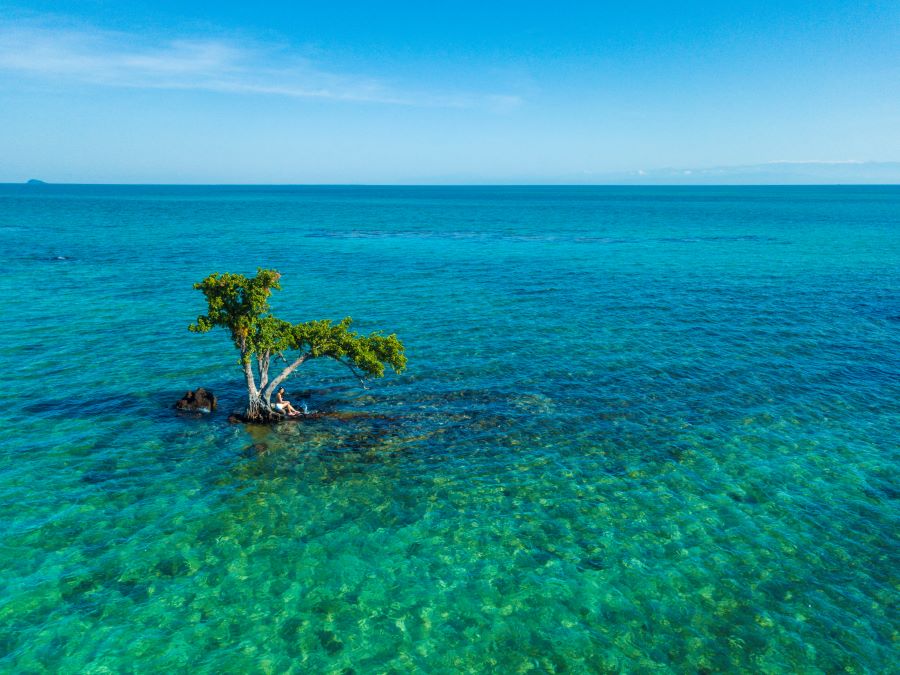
0 186 900 673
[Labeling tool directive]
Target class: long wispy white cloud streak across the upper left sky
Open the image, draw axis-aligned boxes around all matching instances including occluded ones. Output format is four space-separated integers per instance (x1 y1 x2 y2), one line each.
0 22 521 112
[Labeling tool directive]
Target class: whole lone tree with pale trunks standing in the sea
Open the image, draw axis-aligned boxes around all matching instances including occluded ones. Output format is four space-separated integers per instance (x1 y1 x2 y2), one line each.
188 268 406 422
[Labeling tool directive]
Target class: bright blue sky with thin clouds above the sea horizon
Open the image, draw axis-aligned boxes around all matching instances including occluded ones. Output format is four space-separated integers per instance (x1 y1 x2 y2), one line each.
0 0 900 184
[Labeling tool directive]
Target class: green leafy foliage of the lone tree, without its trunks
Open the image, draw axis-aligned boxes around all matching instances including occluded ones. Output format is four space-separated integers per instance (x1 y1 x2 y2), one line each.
188 268 406 377
